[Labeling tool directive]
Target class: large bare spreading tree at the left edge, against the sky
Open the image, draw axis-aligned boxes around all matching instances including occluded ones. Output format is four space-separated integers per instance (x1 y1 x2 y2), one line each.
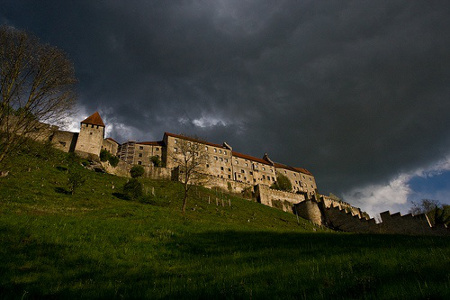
0 26 76 163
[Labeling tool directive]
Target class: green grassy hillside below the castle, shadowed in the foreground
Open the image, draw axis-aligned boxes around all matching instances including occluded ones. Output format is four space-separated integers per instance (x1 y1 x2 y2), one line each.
0 144 450 299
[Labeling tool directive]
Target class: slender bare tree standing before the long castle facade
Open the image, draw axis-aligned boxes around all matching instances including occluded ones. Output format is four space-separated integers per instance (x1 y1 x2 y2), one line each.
177 137 209 214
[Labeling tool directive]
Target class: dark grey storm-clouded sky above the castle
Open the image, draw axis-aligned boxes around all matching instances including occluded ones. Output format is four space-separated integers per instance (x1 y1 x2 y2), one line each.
0 0 450 215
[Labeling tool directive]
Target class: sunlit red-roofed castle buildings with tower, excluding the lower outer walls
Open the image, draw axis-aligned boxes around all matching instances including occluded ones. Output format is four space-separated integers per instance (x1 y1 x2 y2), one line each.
51 112 317 197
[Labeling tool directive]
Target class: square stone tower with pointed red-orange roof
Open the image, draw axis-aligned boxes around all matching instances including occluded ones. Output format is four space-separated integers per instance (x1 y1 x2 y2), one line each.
75 112 105 158
